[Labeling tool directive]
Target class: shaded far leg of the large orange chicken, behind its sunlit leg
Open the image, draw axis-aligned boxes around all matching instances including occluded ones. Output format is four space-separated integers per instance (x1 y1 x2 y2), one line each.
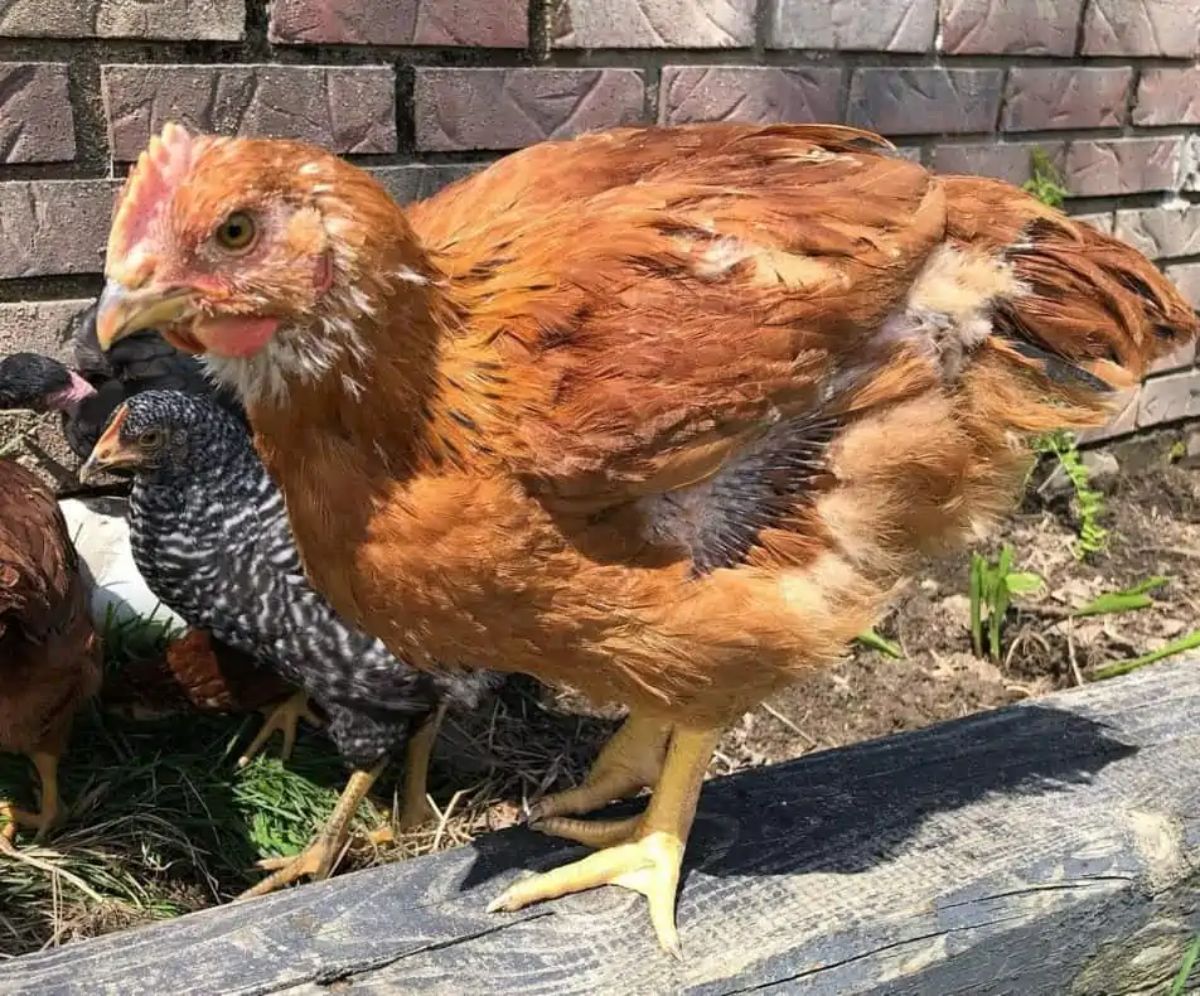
529 714 671 829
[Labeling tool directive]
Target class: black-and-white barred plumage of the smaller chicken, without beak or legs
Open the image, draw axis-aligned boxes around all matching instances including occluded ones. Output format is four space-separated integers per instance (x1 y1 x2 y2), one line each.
112 391 491 767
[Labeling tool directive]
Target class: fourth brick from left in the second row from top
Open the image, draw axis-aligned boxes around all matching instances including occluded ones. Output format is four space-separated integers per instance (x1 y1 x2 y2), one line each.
659 66 841 125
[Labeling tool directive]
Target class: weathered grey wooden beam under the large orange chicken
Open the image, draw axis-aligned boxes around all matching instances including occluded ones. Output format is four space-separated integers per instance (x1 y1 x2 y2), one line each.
0 660 1200 996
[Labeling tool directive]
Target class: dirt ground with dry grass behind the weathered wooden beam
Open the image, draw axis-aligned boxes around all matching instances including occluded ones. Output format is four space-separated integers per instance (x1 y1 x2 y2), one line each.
0 428 1200 958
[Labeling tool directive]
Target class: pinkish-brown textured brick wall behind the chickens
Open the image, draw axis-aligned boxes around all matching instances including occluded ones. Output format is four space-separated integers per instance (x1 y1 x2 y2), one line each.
0 0 1200 468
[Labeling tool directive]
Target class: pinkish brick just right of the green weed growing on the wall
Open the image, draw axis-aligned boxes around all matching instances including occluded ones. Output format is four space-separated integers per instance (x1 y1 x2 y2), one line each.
1063 138 1183 197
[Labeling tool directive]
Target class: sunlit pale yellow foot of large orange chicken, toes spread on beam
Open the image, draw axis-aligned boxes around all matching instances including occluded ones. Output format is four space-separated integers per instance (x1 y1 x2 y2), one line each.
487 817 684 958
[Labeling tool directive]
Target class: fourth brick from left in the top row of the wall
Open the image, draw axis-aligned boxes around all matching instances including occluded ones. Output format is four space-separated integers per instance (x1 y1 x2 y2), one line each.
767 0 937 52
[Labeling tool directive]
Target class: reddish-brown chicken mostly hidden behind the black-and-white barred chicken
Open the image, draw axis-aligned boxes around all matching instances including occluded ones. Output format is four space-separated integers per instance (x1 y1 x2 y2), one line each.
102 629 320 767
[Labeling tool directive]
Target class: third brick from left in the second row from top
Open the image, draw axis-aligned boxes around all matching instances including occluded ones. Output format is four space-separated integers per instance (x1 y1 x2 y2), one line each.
414 68 644 151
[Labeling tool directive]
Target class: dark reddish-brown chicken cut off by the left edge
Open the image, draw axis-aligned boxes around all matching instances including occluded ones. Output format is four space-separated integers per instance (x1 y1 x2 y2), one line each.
0 460 101 841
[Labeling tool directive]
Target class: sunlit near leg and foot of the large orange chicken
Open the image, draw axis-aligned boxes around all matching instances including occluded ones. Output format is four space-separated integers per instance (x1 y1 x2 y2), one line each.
487 726 721 958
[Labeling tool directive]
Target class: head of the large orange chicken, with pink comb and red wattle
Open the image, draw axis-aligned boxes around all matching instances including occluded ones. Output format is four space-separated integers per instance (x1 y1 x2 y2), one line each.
97 125 424 403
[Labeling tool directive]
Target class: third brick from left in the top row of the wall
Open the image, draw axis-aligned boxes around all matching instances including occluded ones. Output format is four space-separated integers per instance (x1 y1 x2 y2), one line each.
551 0 755 48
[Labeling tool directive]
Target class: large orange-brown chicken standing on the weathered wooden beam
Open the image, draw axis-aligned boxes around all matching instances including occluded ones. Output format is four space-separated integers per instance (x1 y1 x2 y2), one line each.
97 125 1198 952
